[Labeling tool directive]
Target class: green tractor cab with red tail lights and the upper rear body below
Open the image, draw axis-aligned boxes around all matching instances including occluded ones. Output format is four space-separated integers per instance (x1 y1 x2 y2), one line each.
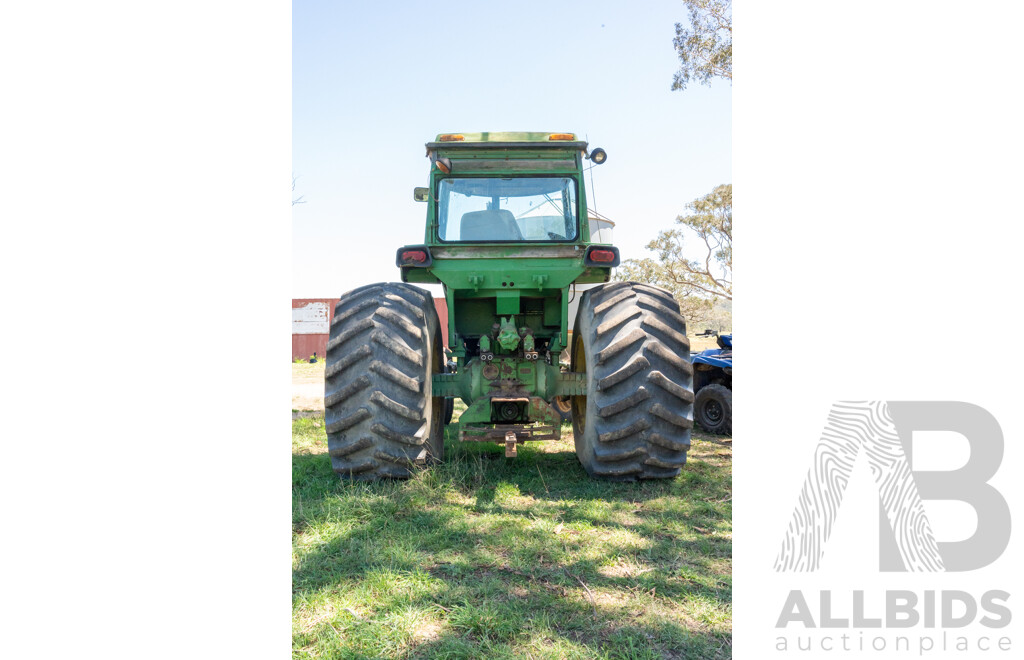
395 132 620 367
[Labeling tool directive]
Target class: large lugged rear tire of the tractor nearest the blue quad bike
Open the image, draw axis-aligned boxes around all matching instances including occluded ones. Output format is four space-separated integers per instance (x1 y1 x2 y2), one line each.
571 282 693 480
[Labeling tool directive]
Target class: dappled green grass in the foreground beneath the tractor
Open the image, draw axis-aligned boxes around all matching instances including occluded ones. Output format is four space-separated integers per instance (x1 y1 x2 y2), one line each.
292 407 732 659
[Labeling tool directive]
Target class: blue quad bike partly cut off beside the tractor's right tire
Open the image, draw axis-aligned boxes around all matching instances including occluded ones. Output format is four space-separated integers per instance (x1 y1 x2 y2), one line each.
690 329 732 435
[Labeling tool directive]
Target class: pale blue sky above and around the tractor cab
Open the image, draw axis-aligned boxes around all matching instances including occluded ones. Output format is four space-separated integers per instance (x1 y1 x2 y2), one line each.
293 0 732 298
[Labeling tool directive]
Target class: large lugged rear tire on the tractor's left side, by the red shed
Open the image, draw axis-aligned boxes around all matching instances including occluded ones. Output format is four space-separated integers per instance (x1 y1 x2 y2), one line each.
324 283 444 480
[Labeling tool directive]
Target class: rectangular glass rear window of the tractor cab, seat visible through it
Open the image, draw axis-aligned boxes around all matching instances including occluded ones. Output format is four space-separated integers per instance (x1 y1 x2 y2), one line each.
437 177 577 243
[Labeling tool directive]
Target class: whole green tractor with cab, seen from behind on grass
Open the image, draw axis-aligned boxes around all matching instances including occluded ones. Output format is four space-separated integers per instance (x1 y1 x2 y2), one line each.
324 133 693 480
